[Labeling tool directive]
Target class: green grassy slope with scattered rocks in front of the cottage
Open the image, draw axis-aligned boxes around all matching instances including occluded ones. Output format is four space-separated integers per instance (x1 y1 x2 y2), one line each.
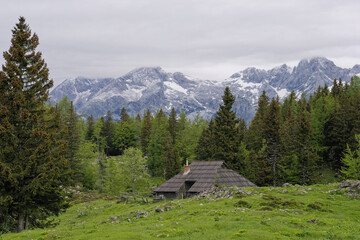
0 184 360 240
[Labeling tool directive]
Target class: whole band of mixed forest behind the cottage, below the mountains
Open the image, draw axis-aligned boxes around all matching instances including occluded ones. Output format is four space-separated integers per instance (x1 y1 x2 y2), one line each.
57 77 360 194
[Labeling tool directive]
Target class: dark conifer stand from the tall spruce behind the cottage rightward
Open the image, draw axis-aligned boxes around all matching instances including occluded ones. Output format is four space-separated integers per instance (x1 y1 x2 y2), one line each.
197 76 360 186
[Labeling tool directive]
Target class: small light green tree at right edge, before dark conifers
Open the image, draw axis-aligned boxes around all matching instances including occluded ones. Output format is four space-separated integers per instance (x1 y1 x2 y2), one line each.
341 134 360 180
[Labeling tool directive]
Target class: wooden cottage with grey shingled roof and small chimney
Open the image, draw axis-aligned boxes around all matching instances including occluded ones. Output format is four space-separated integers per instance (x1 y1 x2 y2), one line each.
154 161 256 198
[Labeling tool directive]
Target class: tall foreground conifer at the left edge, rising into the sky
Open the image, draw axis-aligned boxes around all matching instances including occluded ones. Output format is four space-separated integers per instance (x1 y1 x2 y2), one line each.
0 17 68 232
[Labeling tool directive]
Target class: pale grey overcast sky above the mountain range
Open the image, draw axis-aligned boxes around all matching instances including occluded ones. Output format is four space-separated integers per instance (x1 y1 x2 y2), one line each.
0 0 360 85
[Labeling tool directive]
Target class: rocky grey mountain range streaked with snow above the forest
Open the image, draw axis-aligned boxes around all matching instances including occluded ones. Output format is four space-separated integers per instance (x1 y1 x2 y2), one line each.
50 58 360 122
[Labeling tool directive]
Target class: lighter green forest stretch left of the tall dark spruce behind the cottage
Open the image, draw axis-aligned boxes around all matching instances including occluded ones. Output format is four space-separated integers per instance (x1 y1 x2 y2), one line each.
56 97 206 191
